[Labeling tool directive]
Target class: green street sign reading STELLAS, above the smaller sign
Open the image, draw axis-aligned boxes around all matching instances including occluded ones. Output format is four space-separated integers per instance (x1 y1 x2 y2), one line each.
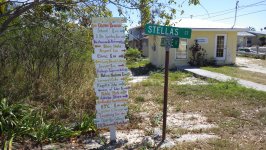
145 24 192 39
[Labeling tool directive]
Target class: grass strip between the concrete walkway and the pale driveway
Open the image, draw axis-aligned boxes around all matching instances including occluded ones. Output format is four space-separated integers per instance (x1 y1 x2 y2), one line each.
202 66 266 85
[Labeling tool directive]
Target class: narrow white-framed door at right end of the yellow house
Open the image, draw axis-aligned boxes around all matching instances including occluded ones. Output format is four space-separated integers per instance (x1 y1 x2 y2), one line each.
215 34 226 60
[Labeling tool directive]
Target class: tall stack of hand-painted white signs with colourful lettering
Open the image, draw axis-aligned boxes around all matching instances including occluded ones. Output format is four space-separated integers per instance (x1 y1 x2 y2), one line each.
92 18 129 128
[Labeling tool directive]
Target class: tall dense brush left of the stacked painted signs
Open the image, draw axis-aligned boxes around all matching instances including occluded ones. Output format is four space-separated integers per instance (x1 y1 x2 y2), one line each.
0 7 96 149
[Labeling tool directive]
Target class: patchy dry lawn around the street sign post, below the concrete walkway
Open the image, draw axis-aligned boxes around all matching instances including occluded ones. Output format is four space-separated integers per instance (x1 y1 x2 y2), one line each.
129 72 266 149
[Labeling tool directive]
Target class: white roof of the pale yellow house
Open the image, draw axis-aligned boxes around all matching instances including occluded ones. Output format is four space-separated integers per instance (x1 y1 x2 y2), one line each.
170 19 248 31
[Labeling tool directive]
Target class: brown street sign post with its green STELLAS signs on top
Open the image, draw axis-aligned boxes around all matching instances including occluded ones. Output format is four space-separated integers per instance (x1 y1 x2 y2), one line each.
145 24 192 142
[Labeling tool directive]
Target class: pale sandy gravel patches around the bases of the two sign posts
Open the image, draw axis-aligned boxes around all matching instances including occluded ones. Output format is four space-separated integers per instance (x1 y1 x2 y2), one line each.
44 112 219 150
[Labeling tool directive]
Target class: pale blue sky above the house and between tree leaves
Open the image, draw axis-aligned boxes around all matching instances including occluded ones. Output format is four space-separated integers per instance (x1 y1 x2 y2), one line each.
108 0 266 31
